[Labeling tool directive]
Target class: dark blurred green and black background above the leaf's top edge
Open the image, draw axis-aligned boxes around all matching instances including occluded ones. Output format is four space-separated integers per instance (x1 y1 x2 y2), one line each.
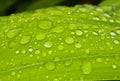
0 0 102 16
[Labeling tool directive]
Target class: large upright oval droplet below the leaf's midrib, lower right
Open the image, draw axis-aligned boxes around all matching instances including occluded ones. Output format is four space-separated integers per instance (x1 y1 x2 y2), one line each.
81 62 92 74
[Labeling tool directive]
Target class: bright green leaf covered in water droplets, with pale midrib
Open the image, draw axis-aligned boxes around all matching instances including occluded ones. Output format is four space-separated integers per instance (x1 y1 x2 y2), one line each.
0 5 120 81
